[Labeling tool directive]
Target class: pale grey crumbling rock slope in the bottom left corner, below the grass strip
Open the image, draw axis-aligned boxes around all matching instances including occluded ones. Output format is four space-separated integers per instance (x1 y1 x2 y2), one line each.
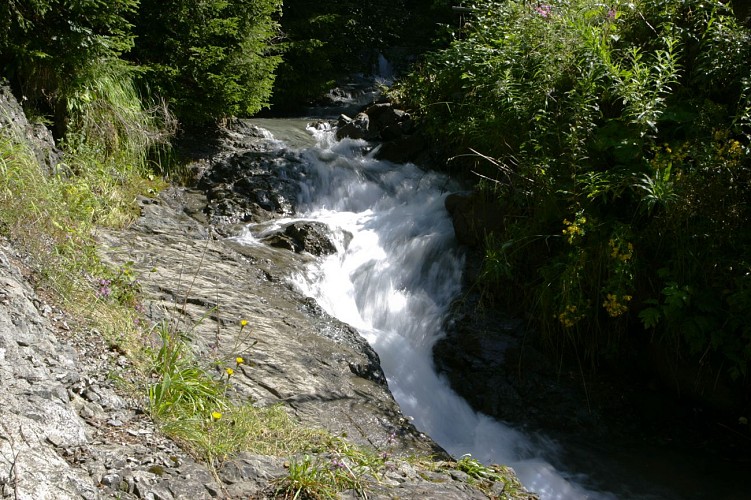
0 240 250 500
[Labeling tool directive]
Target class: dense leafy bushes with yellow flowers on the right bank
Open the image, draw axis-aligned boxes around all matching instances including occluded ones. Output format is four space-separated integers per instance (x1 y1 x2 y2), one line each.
395 0 751 378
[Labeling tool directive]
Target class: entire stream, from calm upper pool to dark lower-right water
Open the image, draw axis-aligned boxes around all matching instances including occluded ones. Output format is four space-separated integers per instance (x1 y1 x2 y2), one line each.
232 119 745 499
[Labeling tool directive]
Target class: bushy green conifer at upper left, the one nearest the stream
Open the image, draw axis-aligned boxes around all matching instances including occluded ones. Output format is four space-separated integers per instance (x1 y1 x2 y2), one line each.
133 0 282 123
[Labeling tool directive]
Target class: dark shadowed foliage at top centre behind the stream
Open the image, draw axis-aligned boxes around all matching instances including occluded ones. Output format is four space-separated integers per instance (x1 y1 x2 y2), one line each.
273 0 451 110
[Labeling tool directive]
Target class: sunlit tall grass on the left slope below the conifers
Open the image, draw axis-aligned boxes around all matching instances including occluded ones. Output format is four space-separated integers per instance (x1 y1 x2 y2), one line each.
0 61 172 297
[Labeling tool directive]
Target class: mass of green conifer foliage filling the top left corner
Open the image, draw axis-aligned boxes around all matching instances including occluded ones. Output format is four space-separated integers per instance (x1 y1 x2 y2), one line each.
0 0 281 132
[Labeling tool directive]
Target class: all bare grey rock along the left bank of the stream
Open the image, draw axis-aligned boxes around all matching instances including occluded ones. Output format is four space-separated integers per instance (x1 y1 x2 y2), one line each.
0 87 533 500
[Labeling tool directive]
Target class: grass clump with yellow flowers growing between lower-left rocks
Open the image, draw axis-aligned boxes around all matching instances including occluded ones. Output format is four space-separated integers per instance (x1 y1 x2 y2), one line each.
147 320 327 466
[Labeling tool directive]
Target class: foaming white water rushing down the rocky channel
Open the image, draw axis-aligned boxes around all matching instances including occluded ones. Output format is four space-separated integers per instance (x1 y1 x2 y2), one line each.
238 123 612 499
